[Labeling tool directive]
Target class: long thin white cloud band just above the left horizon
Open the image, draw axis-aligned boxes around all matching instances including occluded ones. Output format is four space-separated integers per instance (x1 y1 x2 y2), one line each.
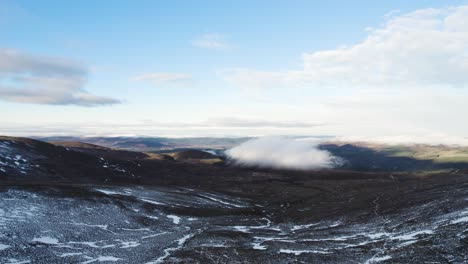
0 115 326 137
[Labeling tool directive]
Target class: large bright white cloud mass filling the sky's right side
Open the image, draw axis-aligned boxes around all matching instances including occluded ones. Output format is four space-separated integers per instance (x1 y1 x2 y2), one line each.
218 6 468 141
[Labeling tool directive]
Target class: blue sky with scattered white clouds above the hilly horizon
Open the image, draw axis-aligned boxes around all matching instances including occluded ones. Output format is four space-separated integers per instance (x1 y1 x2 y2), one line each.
0 0 468 141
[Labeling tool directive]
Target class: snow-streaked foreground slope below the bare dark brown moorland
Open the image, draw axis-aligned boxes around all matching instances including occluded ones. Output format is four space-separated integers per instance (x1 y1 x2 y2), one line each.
0 187 468 264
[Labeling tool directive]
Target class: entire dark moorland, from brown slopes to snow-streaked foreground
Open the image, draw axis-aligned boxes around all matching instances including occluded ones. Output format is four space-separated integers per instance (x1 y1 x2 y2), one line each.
0 137 468 264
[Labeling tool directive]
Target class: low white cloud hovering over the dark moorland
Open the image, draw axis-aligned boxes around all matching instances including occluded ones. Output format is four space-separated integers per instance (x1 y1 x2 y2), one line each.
226 137 342 170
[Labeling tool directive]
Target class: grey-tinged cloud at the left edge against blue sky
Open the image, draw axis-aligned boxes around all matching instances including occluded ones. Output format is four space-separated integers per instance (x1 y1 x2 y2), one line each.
0 49 120 106
